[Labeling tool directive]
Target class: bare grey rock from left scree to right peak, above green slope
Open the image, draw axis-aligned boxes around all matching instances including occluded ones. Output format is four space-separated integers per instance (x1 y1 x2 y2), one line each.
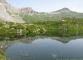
0 0 82 23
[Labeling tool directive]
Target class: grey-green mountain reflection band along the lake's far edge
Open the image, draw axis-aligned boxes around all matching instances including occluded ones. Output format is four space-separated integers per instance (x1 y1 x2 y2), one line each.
0 36 82 50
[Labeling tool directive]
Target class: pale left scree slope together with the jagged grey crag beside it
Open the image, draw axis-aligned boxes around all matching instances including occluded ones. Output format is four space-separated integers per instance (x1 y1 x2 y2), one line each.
0 0 38 23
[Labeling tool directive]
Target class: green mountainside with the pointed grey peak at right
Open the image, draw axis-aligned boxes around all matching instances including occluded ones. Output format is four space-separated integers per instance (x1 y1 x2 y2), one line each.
20 8 83 22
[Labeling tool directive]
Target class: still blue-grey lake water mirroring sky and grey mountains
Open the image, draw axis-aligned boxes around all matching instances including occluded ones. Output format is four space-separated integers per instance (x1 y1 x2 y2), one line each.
5 37 83 60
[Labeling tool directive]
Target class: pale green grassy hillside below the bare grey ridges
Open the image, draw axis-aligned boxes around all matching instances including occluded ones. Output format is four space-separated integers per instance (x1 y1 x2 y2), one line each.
20 12 83 22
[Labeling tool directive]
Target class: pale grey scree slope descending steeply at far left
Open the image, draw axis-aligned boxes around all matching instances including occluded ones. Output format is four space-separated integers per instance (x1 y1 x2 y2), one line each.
0 0 24 23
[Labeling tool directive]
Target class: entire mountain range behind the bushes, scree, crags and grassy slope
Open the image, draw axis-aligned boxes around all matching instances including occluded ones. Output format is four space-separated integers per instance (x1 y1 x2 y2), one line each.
0 0 83 23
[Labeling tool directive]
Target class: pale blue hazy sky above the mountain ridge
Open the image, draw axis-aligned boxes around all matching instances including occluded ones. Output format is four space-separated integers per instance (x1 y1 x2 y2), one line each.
6 0 83 12
